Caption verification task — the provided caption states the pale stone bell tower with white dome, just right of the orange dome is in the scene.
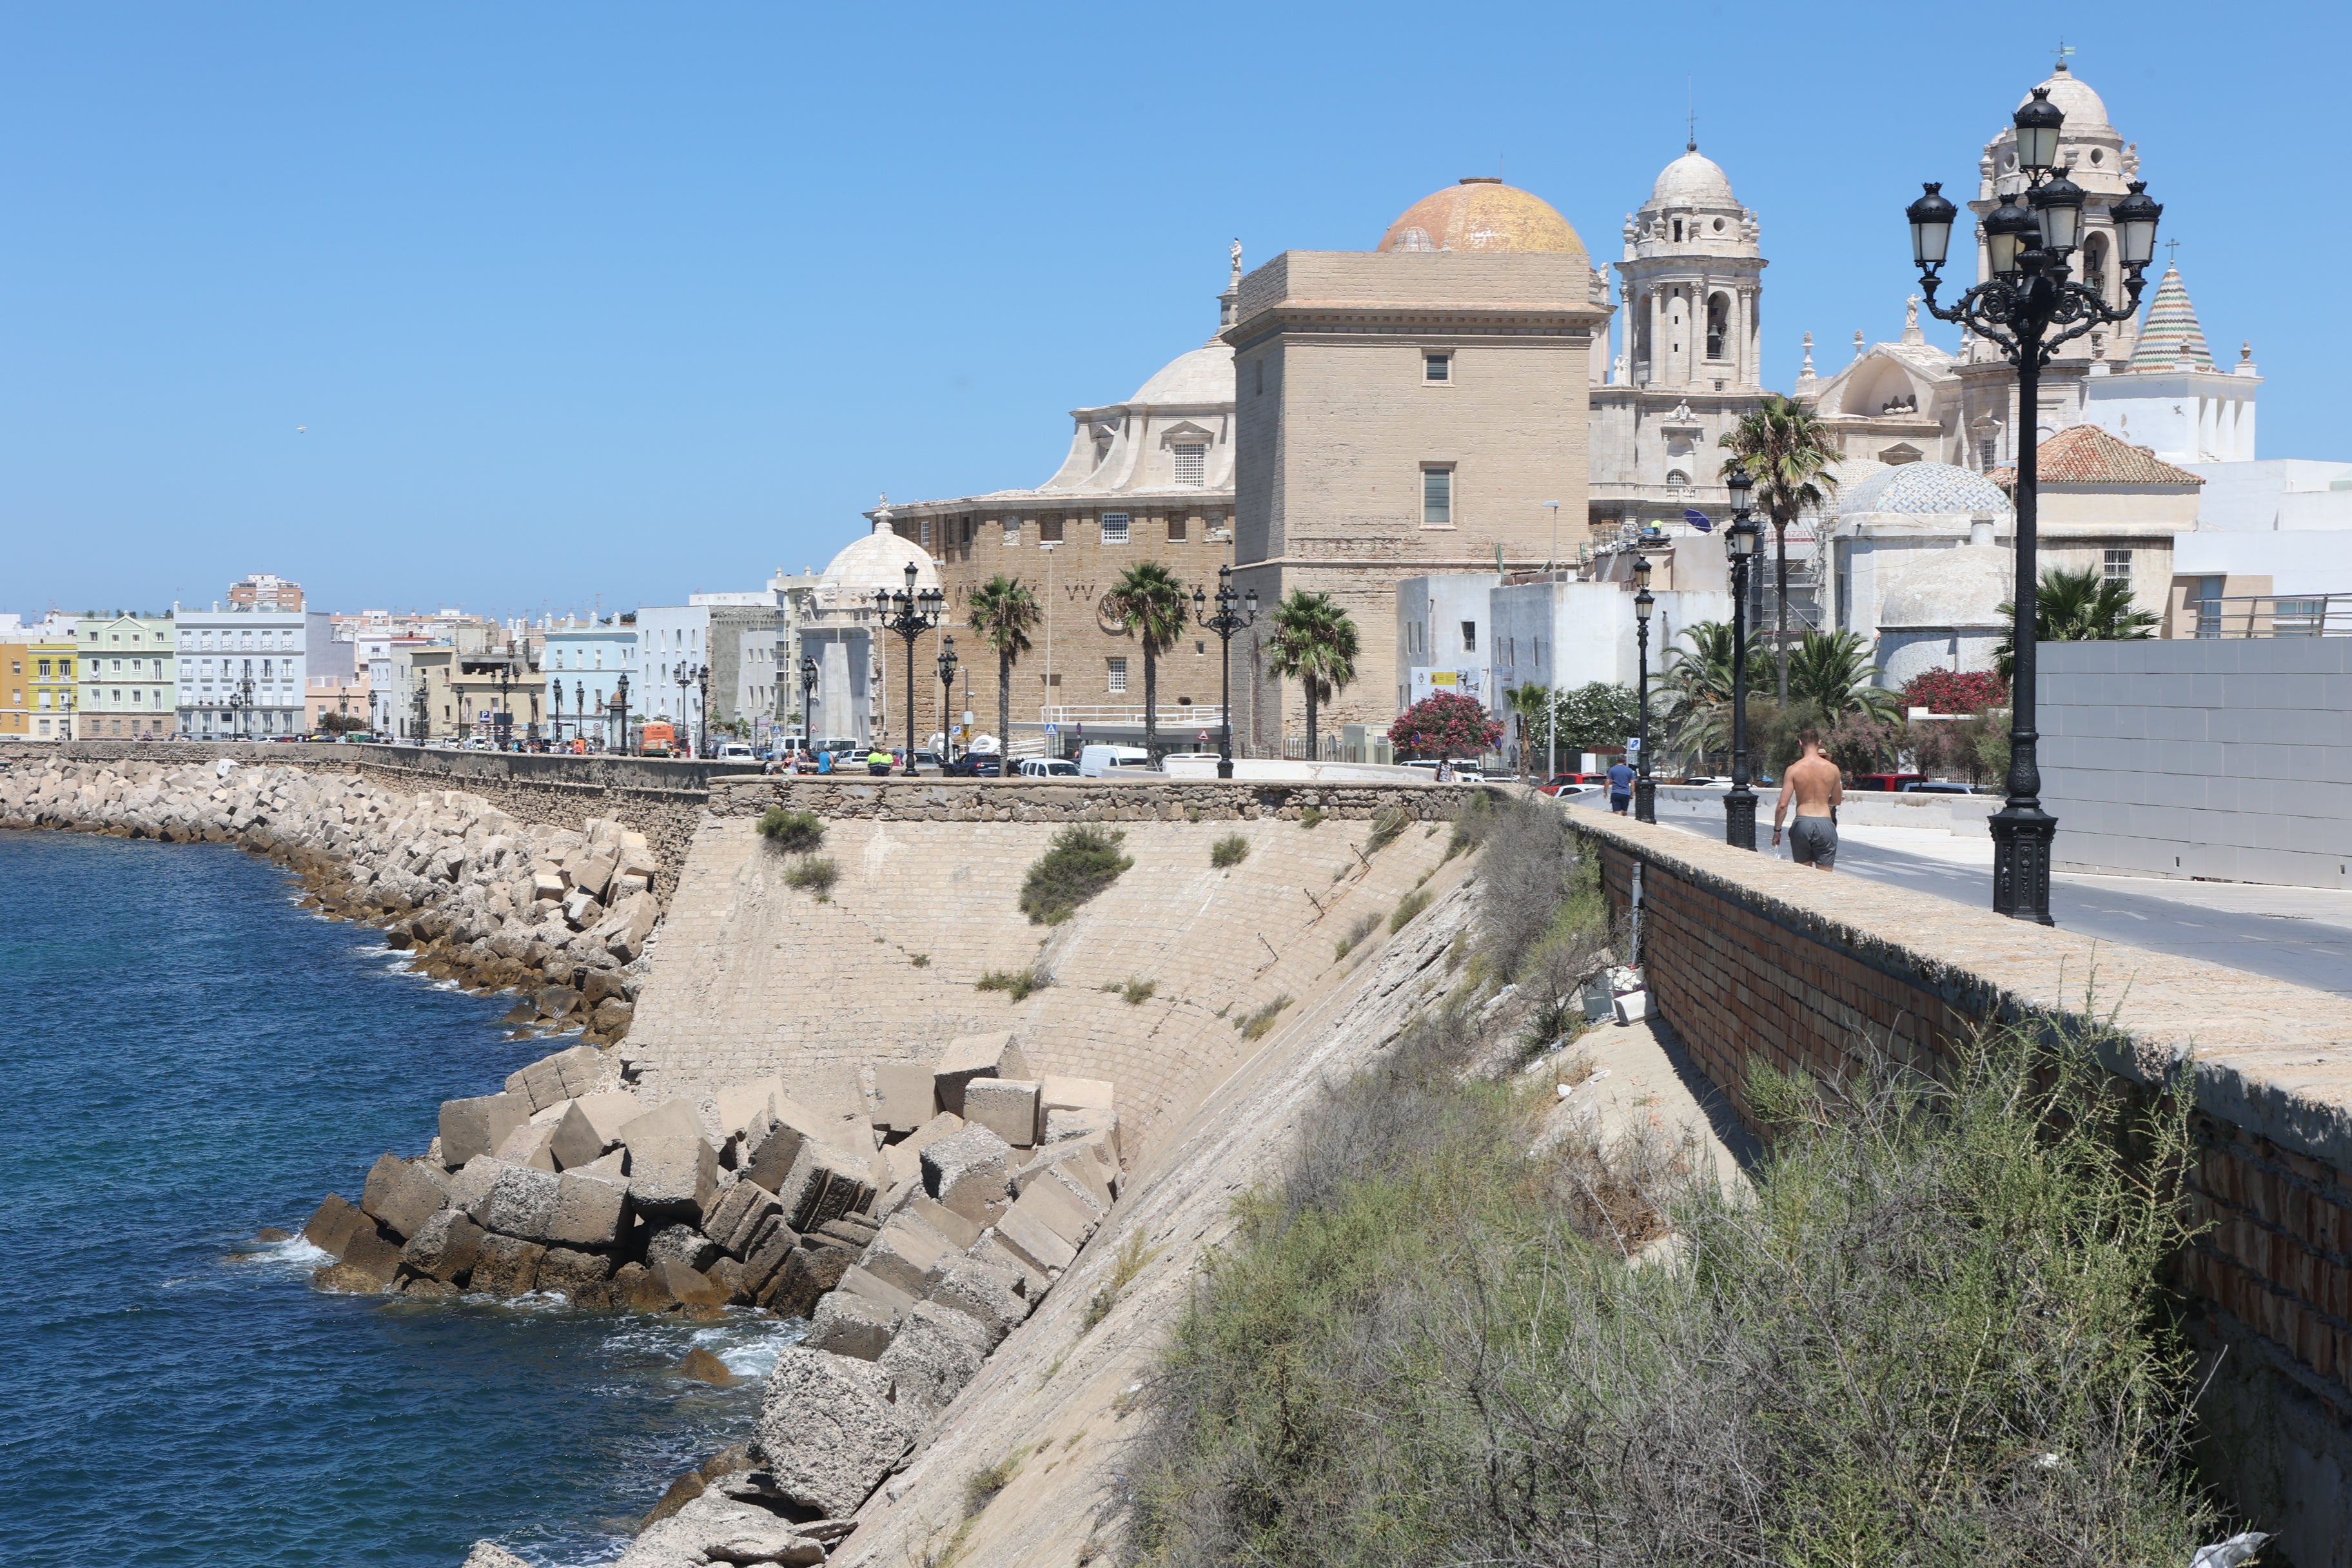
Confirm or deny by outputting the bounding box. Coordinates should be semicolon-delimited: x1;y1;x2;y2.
1614;141;1764;393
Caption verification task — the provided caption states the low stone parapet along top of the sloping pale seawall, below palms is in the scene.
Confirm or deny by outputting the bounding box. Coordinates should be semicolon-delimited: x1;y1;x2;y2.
710;776;1470;823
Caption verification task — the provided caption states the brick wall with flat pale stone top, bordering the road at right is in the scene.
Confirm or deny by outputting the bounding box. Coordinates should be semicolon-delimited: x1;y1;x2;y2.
1571;816;2352;1568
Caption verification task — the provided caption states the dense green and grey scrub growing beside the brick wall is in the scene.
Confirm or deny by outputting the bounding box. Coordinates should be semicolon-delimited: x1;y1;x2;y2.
1122;807;2213;1568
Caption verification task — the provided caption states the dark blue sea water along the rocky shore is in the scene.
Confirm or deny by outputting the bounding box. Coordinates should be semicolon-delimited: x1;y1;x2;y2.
0;832;799;1568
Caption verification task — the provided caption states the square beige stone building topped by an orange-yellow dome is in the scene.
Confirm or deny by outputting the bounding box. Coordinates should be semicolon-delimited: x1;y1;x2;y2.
1223;179;1609;757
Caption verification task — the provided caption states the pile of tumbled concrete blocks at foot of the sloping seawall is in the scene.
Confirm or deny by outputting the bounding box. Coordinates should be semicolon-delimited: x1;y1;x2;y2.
444;1034;1124;1568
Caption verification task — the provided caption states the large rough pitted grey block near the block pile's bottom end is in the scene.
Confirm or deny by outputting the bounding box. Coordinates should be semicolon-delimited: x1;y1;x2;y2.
758;1345;922;1518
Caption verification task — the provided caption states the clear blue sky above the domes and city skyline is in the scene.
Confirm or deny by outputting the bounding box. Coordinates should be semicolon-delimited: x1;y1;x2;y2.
0;3;2352;614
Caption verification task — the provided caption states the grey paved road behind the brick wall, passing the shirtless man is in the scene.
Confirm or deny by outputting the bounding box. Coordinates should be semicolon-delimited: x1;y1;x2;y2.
1571;797;2352;994
